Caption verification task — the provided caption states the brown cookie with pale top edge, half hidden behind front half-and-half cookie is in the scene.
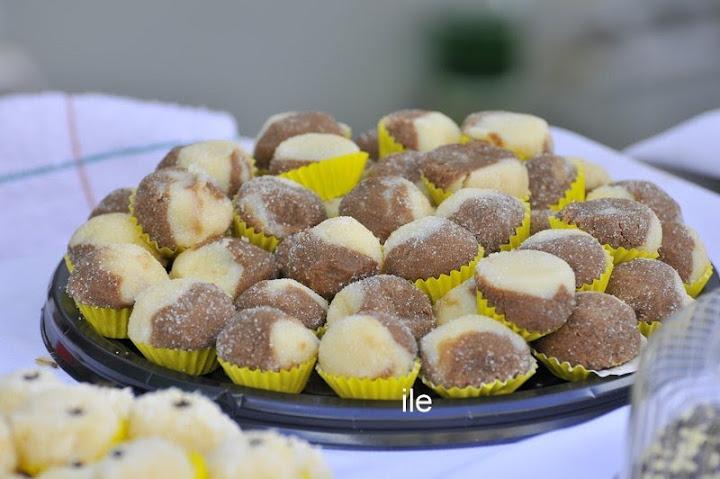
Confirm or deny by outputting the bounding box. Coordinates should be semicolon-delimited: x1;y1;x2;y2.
235;278;328;329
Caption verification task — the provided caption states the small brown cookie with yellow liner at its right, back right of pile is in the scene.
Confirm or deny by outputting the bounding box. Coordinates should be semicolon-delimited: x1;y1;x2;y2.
525;154;585;210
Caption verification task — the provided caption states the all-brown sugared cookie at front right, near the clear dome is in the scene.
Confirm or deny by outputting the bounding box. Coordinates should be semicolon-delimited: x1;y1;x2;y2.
533;292;642;371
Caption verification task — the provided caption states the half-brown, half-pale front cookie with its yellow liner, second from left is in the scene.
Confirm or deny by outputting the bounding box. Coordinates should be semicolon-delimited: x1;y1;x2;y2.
217;306;318;393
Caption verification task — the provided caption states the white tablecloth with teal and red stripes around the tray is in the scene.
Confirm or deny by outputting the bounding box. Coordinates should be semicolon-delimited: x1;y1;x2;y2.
0;93;720;479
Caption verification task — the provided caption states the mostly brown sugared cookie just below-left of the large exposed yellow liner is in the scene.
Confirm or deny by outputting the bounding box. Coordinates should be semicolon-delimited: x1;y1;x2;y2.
233;176;327;239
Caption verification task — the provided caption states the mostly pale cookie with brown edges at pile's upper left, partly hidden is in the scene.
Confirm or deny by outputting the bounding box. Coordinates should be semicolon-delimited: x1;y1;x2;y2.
158;140;255;197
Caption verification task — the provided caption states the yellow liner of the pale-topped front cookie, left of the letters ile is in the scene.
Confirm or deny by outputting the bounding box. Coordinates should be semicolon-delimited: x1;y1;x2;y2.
315;360;420;400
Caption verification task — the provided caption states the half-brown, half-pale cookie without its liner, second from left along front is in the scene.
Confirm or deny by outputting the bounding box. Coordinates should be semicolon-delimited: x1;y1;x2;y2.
217;306;318;371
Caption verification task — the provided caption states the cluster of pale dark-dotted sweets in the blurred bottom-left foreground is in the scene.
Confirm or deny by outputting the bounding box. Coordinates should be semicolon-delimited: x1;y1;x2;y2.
0;369;332;479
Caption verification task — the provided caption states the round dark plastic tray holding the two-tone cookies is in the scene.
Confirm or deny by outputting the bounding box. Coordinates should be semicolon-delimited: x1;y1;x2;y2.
41;262;720;449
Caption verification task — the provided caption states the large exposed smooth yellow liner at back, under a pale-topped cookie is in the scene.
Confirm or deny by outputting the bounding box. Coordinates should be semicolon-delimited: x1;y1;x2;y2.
279;151;368;200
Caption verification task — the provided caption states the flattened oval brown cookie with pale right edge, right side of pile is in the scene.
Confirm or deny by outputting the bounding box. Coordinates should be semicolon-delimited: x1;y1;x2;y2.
556;198;662;251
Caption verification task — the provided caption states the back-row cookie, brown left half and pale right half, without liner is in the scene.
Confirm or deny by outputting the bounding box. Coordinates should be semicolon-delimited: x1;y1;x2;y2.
380;110;460;151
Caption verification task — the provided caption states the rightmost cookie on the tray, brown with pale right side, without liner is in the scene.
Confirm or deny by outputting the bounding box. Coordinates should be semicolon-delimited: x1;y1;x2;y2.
658;222;710;284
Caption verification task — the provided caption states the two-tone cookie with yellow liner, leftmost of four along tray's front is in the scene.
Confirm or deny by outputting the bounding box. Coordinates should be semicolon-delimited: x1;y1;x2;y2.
127;278;235;375
